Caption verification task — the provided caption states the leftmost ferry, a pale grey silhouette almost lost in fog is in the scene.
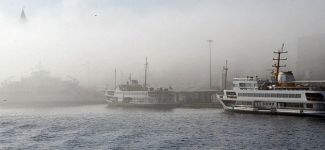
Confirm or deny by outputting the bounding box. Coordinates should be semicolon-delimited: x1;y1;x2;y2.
0;68;105;107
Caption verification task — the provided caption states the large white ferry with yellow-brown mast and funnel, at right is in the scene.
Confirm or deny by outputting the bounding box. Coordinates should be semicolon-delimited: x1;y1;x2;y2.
217;45;325;117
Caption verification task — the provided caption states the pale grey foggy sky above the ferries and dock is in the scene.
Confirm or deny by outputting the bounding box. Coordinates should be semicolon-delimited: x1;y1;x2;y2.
0;0;325;89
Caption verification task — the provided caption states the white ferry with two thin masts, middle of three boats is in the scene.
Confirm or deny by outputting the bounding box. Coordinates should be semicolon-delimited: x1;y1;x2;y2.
105;59;178;108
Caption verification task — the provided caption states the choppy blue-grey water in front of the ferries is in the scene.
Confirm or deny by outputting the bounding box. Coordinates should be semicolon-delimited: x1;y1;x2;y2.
0;105;325;149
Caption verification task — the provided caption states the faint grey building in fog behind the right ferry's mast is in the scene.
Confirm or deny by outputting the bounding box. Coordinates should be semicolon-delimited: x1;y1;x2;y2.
295;34;325;80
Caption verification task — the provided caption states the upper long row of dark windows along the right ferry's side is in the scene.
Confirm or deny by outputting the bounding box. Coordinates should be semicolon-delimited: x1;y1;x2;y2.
238;93;301;98
